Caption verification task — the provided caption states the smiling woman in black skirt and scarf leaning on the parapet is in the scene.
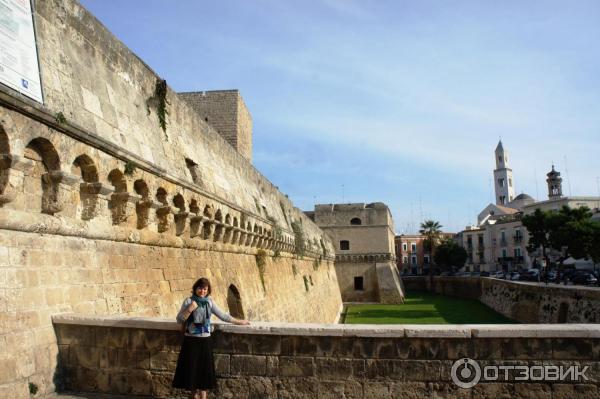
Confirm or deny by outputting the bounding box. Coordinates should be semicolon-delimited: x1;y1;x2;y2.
173;277;250;399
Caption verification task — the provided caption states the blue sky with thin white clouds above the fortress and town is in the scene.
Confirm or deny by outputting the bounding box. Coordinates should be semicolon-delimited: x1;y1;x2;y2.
82;0;600;233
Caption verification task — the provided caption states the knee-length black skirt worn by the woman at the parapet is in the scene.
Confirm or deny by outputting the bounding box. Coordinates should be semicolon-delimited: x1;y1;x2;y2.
173;335;217;391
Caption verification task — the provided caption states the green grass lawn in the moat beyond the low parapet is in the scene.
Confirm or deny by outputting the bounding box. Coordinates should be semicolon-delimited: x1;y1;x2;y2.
345;291;515;324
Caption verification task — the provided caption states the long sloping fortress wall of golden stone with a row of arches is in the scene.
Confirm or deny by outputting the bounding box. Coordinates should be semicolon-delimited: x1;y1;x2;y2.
0;0;341;398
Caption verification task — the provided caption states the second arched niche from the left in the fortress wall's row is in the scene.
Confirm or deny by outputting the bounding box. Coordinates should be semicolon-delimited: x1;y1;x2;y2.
24;137;63;215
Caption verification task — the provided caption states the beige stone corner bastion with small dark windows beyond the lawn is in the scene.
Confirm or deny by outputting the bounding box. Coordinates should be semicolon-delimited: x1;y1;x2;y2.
307;202;404;303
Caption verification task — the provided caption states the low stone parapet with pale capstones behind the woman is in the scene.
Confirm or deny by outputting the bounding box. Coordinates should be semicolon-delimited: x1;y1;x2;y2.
53;314;600;398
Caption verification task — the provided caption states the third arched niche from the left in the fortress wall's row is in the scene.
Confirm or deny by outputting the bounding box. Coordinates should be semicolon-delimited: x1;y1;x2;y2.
71;154;100;220
